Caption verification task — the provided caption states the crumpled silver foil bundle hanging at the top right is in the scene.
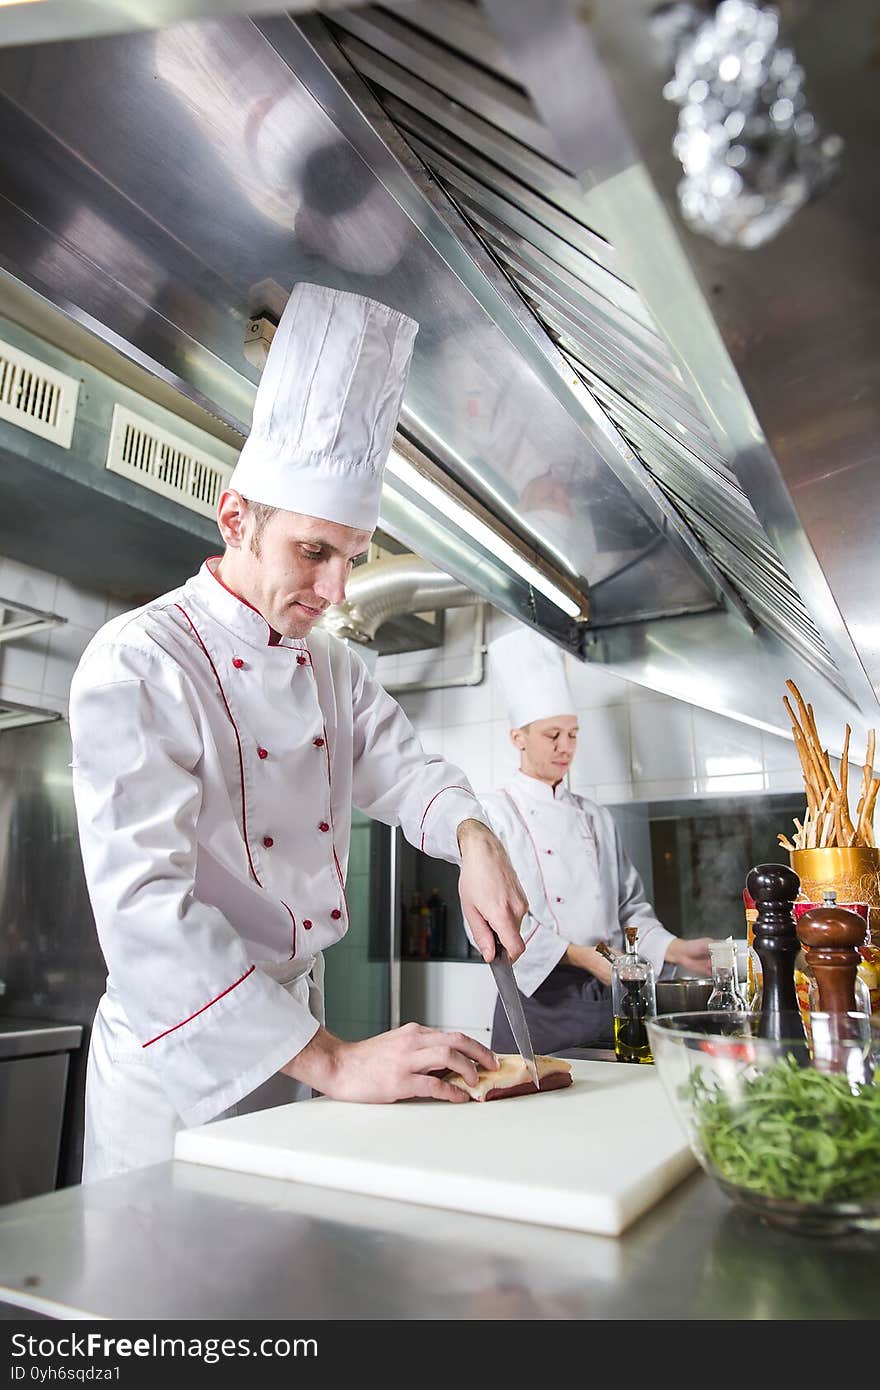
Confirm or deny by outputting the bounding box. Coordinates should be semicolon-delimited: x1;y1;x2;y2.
663;0;844;247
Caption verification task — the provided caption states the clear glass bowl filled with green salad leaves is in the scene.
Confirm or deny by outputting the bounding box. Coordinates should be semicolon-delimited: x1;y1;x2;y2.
646;1012;880;1236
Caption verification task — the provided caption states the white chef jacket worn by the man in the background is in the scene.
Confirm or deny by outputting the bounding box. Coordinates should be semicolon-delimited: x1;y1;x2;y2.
480;771;674;998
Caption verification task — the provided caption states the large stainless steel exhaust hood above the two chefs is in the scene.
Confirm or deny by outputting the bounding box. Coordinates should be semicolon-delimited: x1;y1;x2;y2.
0;0;880;761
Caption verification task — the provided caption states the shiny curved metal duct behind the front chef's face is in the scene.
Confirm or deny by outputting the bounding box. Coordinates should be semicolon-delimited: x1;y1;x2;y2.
323;555;481;645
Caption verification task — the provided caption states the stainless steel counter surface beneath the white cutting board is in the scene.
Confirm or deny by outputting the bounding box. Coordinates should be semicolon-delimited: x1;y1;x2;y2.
0;1162;880;1322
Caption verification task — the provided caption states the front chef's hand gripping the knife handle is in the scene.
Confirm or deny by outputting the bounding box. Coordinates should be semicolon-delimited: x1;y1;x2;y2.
459;820;528;960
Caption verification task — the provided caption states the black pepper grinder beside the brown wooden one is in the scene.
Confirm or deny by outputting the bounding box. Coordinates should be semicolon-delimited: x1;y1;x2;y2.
745;865;805;1040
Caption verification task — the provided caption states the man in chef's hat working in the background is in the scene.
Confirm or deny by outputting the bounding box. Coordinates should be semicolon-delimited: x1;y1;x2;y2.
481;627;710;1054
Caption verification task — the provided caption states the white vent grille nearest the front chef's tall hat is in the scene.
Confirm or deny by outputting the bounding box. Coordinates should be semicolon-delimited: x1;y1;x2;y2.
107;406;232;518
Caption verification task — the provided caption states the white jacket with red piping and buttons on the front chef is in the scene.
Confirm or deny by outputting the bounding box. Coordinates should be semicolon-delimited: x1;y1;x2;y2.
70;557;487;1161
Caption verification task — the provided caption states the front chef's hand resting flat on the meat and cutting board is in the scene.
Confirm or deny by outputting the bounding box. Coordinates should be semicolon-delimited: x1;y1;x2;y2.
281;1023;498;1105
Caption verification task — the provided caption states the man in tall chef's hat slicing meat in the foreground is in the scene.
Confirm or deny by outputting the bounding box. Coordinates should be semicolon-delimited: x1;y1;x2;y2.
70;284;527;1180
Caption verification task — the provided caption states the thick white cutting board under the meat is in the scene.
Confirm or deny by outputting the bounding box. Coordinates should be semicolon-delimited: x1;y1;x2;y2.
175;1062;696;1236
